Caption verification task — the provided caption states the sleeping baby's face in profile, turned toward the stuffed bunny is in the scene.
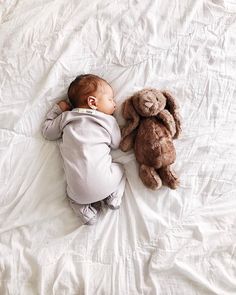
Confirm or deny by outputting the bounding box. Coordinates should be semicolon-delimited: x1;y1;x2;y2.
94;82;116;115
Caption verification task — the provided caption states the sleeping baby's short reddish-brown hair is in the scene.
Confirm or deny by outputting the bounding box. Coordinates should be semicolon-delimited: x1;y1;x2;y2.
67;74;108;108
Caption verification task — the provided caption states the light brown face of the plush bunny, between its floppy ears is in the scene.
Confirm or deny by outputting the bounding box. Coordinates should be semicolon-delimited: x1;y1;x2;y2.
132;89;166;117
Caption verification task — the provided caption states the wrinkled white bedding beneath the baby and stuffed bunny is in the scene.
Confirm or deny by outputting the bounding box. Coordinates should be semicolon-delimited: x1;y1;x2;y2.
0;0;236;295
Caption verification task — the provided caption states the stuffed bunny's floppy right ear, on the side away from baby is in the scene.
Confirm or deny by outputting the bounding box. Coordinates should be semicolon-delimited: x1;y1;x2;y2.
162;90;182;139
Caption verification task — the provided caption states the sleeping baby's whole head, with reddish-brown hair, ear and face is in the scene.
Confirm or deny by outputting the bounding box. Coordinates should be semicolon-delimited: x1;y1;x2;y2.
68;74;115;115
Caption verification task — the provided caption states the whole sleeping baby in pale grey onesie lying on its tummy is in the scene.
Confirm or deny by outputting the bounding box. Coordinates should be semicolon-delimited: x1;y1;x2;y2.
42;74;125;225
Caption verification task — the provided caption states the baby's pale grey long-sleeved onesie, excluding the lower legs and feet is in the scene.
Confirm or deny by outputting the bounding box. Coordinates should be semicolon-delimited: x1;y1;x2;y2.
42;104;124;204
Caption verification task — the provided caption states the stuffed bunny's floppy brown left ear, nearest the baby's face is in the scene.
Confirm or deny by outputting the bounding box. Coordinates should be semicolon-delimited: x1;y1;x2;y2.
122;97;139;138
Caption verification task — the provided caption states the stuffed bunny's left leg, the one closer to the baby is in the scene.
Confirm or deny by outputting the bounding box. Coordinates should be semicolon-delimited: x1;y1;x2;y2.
139;164;162;190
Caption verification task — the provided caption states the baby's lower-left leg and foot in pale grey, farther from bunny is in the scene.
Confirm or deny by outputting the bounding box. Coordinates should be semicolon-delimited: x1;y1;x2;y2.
69;198;98;225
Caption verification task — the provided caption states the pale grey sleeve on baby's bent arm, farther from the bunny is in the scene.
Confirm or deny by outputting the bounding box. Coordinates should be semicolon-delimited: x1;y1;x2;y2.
42;104;63;140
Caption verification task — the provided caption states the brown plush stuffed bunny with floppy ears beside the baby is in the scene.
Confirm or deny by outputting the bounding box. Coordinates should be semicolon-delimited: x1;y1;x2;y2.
120;89;181;189
